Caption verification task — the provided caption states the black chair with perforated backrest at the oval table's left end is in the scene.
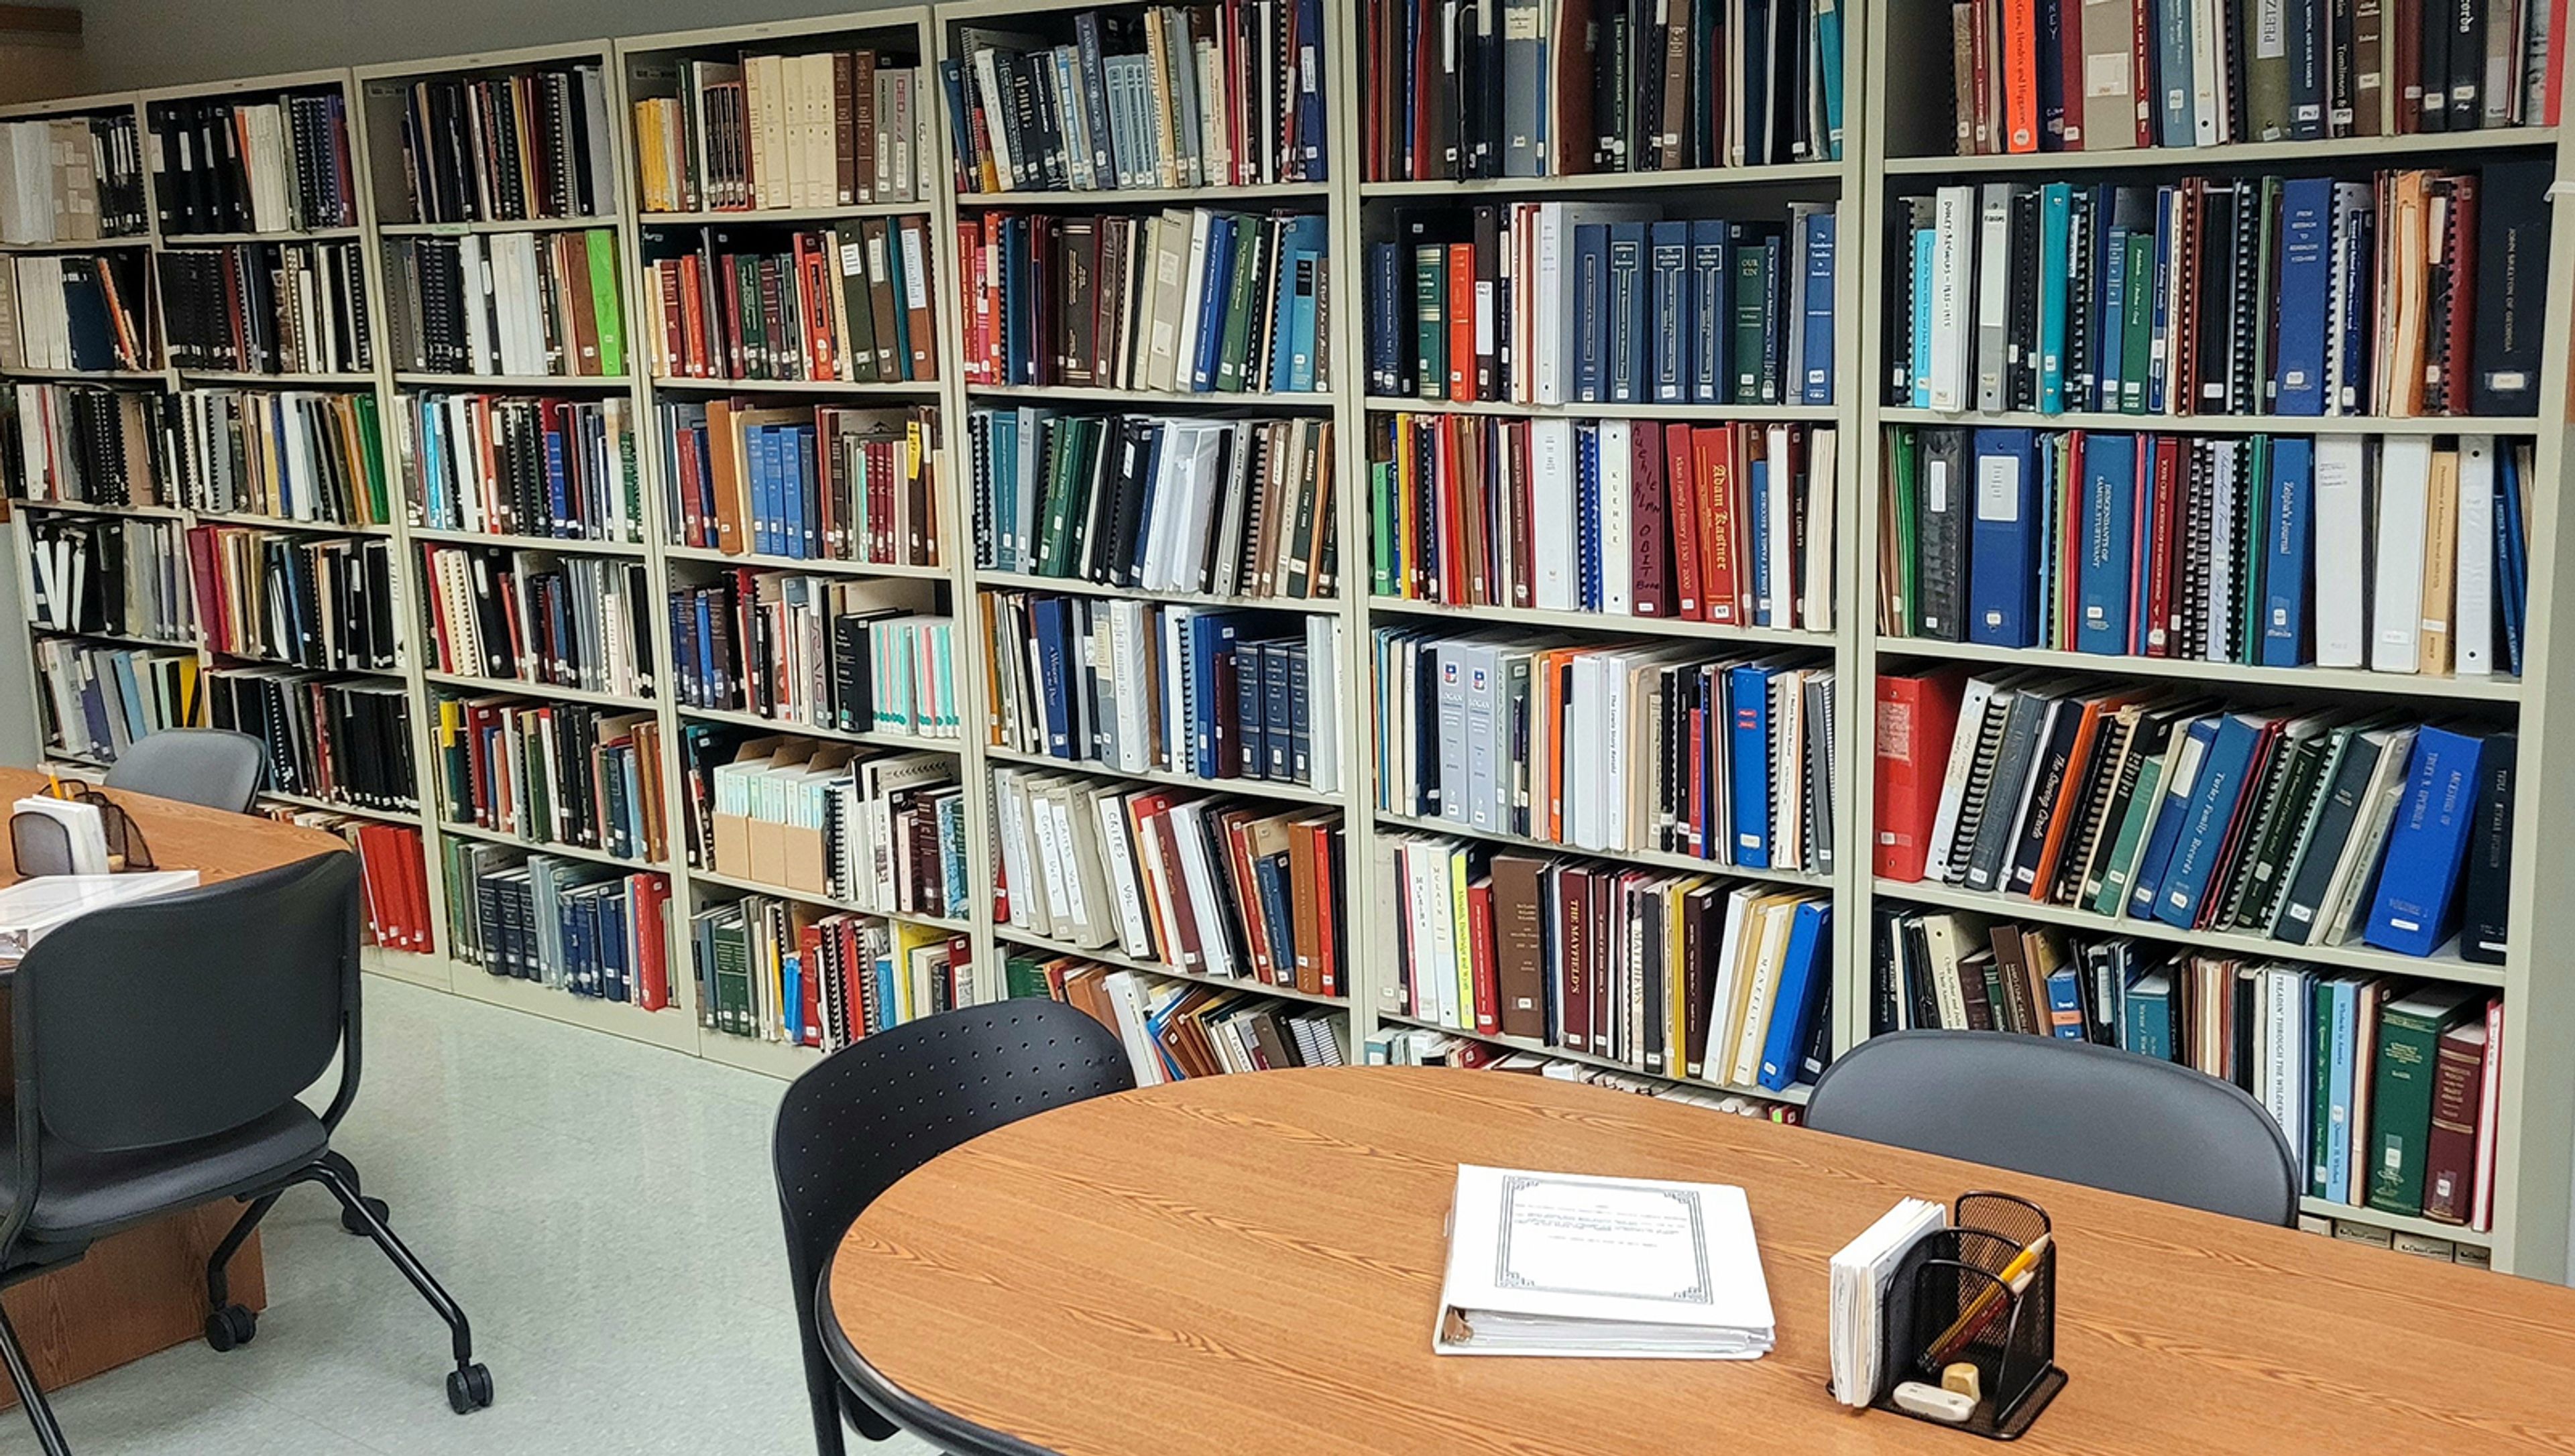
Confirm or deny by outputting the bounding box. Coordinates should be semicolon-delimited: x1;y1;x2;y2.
772;998;1135;1456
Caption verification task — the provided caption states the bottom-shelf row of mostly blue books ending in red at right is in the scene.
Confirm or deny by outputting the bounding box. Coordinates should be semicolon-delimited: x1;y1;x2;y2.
445;839;669;1011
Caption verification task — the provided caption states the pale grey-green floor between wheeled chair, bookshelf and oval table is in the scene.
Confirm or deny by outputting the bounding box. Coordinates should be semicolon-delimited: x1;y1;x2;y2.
0;977;929;1456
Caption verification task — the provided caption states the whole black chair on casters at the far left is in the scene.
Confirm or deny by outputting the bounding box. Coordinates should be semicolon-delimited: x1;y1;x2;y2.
0;854;492;1456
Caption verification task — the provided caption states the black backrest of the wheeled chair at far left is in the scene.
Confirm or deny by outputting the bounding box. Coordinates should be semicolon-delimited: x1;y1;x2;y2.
13;851;361;1152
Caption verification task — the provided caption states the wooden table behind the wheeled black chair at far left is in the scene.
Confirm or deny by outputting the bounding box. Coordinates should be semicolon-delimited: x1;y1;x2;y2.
0;769;347;1410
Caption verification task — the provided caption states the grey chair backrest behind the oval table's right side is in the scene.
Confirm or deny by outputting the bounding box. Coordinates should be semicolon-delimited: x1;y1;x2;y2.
1805;1032;2297;1225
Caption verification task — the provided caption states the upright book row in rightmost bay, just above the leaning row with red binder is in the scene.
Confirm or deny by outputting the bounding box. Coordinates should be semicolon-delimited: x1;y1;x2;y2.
1880;427;2534;676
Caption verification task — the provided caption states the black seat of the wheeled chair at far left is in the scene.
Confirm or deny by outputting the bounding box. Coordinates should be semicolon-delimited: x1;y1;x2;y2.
0;1103;330;1242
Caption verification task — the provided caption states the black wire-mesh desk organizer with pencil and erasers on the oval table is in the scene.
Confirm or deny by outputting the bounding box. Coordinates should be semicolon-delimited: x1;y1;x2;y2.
1870;1194;2065;1441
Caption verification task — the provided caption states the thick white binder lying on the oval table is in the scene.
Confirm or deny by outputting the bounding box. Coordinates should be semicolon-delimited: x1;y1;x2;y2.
1432;1165;1774;1361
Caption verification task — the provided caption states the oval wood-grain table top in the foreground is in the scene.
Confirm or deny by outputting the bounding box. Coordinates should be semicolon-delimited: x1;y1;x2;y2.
832;1068;2575;1456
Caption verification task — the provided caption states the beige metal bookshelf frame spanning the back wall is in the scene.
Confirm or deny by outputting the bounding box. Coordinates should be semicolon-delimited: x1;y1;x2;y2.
0;0;2575;1276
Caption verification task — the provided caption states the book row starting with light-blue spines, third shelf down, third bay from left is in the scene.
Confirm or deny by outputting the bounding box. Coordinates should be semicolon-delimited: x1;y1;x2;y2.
394;393;644;546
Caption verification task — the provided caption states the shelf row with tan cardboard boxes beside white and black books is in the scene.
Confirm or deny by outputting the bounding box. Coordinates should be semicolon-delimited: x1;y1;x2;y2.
680;723;971;918
